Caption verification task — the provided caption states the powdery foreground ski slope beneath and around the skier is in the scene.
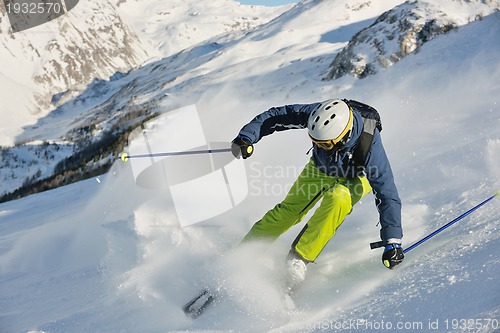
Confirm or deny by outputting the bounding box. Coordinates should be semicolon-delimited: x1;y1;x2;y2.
0;5;500;333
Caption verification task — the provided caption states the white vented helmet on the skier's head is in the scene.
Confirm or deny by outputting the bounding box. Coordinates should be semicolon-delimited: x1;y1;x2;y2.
307;99;353;144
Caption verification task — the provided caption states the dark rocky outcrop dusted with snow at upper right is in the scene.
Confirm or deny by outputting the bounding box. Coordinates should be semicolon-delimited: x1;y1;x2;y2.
326;0;500;80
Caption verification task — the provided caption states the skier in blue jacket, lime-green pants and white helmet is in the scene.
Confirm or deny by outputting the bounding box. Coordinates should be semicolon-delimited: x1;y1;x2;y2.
232;99;404;293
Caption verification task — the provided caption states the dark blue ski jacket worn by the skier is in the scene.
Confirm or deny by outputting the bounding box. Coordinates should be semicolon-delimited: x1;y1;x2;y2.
239;103;403;243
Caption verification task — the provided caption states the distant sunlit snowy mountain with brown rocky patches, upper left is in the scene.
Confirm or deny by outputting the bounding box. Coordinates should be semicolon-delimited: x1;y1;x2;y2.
0;0;288;146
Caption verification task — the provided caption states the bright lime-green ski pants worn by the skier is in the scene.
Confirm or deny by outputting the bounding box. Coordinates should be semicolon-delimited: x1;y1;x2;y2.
243;160;371;261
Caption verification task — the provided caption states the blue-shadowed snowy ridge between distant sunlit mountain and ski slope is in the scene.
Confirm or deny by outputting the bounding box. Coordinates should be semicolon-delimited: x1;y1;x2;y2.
0;0;401;200
